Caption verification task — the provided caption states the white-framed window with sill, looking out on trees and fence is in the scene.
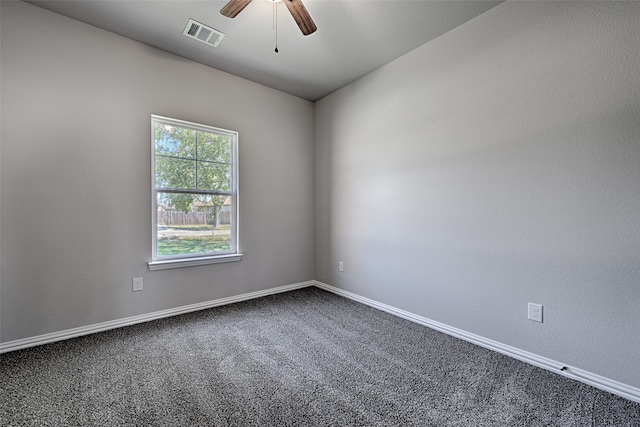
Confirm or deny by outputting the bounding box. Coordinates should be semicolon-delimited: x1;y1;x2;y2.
149;116;242;270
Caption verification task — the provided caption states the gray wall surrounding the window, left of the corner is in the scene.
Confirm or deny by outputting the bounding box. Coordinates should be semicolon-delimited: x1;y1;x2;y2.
0;1;314;342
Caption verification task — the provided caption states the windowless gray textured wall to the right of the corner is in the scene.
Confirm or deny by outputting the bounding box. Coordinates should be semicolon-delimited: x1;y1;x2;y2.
315;2;640;387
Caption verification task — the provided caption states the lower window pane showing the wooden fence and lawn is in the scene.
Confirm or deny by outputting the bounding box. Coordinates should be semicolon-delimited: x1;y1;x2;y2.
157;192;232;256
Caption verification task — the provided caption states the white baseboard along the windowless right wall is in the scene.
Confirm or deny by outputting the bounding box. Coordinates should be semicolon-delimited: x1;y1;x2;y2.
313;280;640;403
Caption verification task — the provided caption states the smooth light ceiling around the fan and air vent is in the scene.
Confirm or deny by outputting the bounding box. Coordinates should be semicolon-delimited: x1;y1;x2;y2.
28;0;500;101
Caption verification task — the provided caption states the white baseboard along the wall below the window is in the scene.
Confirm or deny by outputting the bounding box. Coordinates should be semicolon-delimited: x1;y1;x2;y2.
0;281;314;353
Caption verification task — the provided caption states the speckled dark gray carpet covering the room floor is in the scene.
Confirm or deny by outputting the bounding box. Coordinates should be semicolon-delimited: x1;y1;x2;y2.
0;288;640;426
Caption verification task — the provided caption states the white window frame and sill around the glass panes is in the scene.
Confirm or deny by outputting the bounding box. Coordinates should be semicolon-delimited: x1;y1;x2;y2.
148;115;242;270
